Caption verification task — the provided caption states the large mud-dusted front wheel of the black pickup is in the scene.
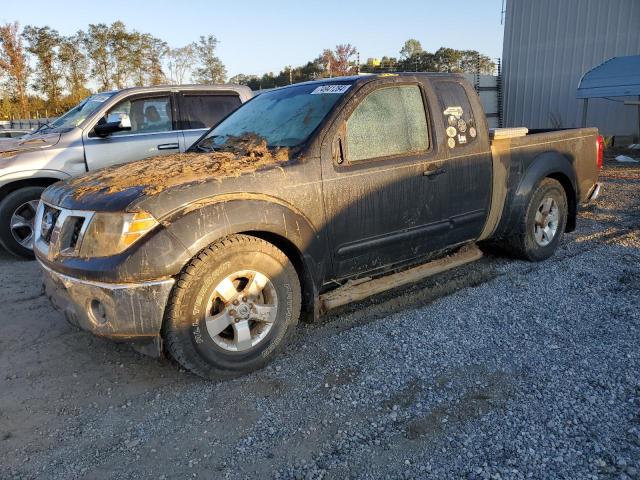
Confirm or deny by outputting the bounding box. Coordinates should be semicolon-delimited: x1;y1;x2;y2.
163;235;301;379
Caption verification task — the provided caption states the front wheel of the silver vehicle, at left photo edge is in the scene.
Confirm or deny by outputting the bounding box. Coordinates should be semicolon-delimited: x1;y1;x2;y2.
0;187;44;259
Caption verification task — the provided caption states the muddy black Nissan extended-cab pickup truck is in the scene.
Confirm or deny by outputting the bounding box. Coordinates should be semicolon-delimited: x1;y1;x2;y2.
34;74;602;378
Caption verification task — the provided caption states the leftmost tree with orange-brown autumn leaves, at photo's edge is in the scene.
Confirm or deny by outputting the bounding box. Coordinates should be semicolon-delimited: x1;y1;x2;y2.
0;22;29;117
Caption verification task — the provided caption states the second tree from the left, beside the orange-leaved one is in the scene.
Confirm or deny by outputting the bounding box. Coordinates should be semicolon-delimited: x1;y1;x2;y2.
22;25;62;108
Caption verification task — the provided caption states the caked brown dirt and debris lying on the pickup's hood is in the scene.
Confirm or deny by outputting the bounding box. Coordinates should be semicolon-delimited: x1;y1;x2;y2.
69;135;289;198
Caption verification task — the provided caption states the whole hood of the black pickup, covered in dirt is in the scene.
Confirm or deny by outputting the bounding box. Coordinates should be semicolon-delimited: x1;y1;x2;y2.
42;140;289;213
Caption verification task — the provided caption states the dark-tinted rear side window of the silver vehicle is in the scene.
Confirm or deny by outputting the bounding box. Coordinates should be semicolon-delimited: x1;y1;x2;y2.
180;94;240;130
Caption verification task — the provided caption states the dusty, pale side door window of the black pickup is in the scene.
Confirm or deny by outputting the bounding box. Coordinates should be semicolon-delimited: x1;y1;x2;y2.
346;85;429;161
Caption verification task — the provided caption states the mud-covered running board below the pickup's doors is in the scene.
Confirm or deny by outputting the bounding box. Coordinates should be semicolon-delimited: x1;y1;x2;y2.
320;244;482;312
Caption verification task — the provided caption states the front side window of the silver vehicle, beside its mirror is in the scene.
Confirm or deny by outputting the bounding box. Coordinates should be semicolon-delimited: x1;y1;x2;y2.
107;96;173;136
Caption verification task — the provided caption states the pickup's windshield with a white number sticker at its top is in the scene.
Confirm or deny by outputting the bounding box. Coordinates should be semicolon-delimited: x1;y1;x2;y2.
196;83;351;150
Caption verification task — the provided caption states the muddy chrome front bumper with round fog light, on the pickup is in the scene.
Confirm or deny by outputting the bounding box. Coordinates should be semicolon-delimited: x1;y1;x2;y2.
40;262;175;350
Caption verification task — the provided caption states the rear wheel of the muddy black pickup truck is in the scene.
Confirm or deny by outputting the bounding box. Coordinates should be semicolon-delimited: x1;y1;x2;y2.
506;178;568;262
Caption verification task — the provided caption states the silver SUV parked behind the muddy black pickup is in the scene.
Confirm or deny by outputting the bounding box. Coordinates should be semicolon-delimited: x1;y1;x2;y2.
0;85;252;258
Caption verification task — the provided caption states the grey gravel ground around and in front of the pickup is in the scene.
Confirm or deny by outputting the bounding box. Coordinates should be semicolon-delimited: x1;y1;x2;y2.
0;158;640;479
